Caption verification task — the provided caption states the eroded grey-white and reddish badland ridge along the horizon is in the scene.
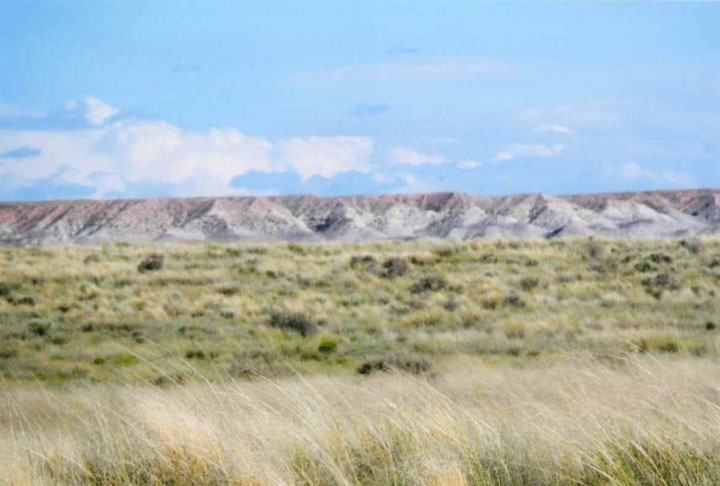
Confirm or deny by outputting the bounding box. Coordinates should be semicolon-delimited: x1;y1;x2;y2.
0;190;720;246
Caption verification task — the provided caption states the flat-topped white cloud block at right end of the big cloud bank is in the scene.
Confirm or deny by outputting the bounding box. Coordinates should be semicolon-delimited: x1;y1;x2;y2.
280;137;373;180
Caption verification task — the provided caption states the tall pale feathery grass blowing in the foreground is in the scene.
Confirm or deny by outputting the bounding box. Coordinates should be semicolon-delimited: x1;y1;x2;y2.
0;356;720;486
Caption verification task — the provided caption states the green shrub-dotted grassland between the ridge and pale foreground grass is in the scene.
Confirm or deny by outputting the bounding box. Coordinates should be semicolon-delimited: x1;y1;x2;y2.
0;240;720;383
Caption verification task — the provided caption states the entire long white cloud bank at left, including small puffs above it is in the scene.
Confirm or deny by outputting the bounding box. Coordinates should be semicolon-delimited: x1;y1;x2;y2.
0;111;372;198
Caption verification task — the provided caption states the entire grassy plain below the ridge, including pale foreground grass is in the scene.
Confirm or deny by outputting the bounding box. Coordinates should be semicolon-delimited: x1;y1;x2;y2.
0;239;720;486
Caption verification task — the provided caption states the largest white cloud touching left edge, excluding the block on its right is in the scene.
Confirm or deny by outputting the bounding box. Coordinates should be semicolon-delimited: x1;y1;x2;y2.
0;122;273;197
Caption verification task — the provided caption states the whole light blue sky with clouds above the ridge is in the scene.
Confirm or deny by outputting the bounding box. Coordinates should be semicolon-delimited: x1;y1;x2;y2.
0;0;720;201
